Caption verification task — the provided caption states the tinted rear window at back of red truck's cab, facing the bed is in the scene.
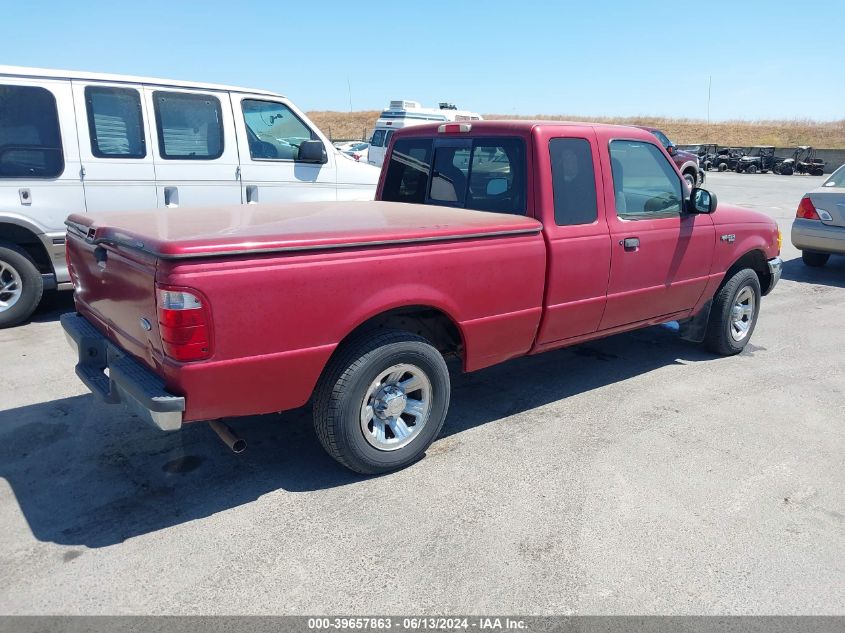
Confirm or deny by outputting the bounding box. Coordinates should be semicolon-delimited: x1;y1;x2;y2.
382;138;526;215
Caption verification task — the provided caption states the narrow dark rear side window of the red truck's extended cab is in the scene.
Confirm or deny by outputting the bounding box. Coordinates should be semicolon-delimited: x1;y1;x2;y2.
549;138;598;226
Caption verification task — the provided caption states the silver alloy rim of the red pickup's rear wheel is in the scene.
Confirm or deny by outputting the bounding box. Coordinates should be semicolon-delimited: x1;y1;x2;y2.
361;363;432;451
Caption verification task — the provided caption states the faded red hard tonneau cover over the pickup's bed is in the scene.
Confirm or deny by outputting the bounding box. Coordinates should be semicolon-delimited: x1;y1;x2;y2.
66;201;542;259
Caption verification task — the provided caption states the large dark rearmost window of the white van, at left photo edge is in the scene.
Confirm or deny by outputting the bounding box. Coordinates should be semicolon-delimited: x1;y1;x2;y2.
0;85;65;178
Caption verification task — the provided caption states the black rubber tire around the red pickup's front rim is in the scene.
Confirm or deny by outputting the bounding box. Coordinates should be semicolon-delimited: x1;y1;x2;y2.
704;268;762;356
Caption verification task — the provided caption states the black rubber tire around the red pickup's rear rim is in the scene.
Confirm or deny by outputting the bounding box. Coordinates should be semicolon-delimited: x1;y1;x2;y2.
314;330;450;475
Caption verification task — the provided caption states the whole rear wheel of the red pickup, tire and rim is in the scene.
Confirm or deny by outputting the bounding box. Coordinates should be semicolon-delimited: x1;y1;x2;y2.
314;330;450;475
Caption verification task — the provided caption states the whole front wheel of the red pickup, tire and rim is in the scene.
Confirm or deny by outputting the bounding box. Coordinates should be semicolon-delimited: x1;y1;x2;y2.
704;268;762;356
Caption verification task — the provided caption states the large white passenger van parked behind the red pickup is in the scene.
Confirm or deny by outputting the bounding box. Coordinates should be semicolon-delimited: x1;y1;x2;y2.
0;66;379;327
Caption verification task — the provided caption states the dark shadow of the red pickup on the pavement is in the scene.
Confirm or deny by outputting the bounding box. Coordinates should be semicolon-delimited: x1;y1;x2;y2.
0;327;714;547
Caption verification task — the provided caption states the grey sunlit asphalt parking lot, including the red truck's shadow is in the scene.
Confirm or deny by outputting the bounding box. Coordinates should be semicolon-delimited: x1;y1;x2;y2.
0;173;845;614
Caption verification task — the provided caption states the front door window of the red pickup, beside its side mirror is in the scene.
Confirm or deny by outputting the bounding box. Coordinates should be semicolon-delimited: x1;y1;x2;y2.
610;141;683;220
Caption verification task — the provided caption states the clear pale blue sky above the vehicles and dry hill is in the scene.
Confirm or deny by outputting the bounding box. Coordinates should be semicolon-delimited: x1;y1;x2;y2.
0;0;845;121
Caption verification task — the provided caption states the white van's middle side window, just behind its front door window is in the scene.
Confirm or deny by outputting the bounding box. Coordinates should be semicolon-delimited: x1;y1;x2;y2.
153;90;223;160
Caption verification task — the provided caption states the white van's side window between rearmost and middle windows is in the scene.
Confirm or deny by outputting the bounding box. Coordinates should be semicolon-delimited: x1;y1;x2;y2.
85;86;147;158
